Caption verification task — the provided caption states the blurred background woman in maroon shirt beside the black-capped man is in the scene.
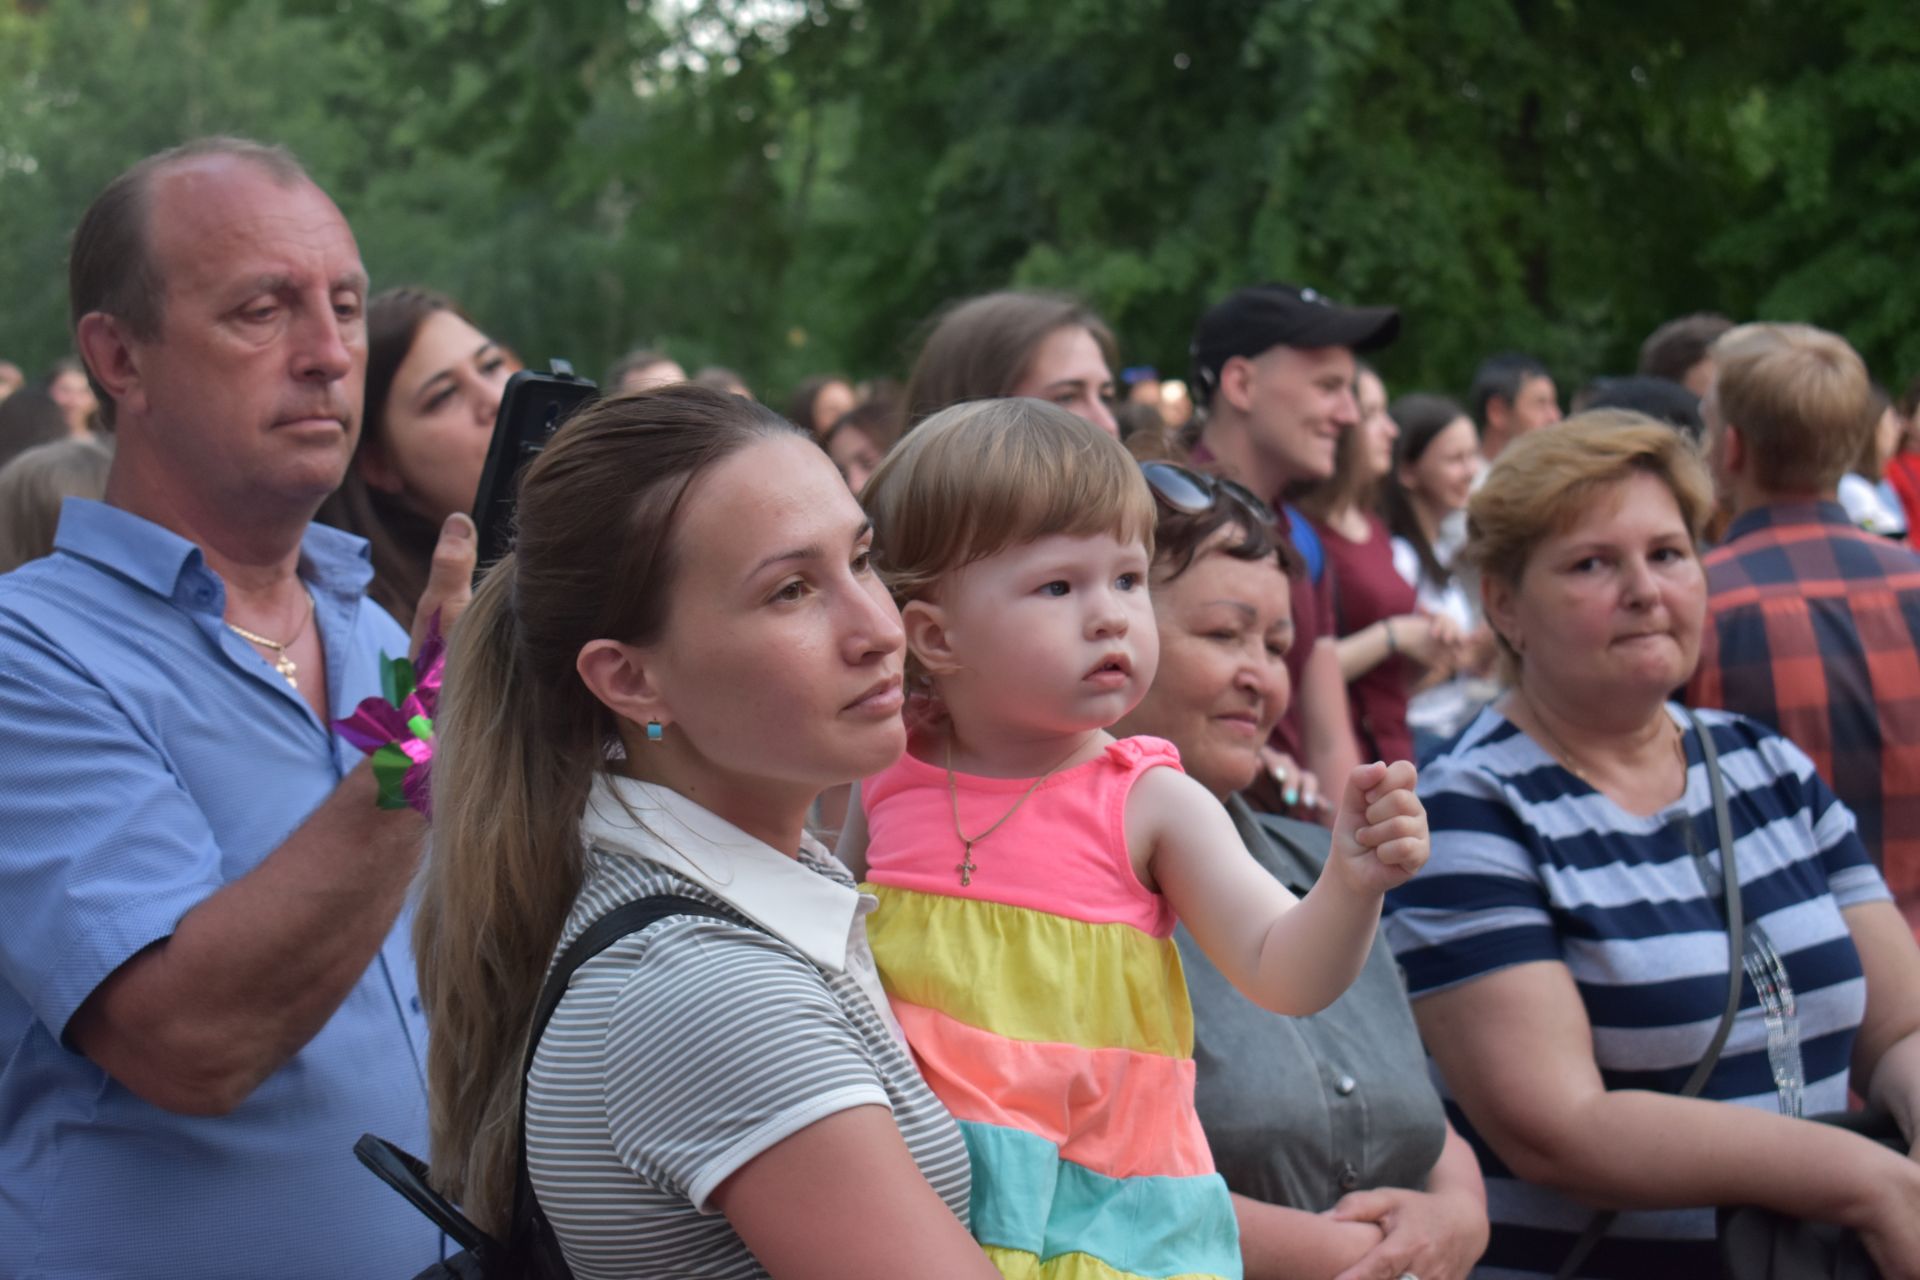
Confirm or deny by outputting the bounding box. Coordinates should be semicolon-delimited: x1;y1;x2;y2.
1300;365;1459;762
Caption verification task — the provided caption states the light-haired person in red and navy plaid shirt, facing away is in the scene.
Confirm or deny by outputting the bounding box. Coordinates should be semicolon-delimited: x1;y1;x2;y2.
1686;324;1920;931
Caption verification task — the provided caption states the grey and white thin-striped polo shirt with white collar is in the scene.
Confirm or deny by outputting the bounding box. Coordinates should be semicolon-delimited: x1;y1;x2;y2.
526;777;970;1280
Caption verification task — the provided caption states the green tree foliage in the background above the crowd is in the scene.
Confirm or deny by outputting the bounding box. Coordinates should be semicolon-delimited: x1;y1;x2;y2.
0;0;1920;401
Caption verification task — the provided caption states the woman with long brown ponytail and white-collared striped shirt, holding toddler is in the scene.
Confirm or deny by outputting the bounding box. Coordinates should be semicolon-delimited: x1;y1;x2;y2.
415;386;995;1280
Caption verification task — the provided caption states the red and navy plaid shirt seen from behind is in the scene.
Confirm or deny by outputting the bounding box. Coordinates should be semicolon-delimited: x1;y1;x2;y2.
1686;503;1920;927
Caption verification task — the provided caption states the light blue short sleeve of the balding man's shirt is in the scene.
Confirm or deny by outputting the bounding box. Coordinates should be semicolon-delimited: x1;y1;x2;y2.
0;618;226;1038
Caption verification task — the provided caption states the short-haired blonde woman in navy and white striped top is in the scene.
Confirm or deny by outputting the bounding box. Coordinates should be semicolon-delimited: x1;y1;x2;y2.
1388;411;1920;1280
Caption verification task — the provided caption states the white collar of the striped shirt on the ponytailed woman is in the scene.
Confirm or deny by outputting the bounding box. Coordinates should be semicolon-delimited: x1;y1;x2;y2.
580;773;860;973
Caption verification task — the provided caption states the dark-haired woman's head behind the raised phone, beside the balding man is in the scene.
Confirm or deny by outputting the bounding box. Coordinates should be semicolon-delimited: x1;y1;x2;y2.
319;286;520;629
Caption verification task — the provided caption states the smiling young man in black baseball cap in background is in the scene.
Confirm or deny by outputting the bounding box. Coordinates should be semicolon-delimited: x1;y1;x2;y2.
1190;284;1400;818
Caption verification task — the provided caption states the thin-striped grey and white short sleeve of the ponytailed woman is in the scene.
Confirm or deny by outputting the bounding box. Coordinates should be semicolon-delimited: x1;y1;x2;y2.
603;921;891;1213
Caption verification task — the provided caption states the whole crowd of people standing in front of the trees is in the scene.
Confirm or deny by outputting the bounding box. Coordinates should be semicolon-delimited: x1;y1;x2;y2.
0;140;1920;1280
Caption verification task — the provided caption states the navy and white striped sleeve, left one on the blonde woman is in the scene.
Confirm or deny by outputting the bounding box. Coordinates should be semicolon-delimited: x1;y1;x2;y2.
1384;756;1563;998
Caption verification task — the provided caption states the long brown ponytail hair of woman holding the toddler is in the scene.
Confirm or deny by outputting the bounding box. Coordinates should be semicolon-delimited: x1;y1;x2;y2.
413;386;801;1230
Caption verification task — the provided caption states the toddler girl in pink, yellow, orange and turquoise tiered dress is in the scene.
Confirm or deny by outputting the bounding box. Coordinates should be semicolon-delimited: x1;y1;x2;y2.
841;399;1427;1280
